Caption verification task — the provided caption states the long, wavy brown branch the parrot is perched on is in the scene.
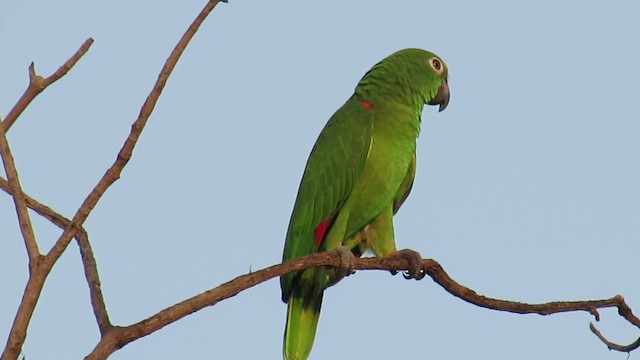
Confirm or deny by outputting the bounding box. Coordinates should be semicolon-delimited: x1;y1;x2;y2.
85;251;640;360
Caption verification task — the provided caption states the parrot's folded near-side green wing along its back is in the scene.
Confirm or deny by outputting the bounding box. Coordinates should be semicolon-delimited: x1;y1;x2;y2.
280;95;373;301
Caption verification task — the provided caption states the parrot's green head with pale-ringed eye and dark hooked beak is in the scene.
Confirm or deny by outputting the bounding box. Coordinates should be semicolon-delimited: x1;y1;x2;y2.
356;48;450;111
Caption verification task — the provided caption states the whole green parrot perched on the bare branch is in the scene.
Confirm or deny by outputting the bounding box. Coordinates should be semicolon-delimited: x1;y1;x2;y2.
280;49;449;360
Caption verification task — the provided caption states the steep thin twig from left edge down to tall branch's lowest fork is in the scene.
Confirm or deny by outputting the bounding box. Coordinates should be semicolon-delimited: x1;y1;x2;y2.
0;111;40;262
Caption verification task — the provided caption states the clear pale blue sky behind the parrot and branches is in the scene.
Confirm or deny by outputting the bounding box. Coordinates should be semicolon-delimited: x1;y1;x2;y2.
0;0;640;360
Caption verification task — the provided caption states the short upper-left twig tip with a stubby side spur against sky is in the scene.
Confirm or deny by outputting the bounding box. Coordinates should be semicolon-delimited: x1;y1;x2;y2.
2;38;93;132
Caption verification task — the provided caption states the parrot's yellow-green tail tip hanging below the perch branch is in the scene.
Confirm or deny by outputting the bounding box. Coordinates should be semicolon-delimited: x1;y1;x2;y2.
283;289;323;360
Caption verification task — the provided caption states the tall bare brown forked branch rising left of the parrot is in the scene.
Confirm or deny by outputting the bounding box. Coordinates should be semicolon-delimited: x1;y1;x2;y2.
0;0;228;360
